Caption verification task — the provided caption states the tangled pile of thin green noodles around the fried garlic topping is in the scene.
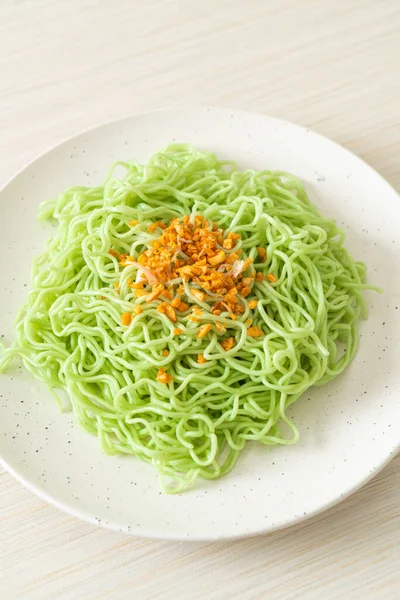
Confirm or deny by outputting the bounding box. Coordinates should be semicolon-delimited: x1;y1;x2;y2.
0;145;376;492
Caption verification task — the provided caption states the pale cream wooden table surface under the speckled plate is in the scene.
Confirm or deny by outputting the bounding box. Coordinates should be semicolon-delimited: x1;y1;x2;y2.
0;0;400;600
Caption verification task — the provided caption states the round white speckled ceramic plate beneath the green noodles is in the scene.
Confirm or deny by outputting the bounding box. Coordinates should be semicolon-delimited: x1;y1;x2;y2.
0;109;400;540
